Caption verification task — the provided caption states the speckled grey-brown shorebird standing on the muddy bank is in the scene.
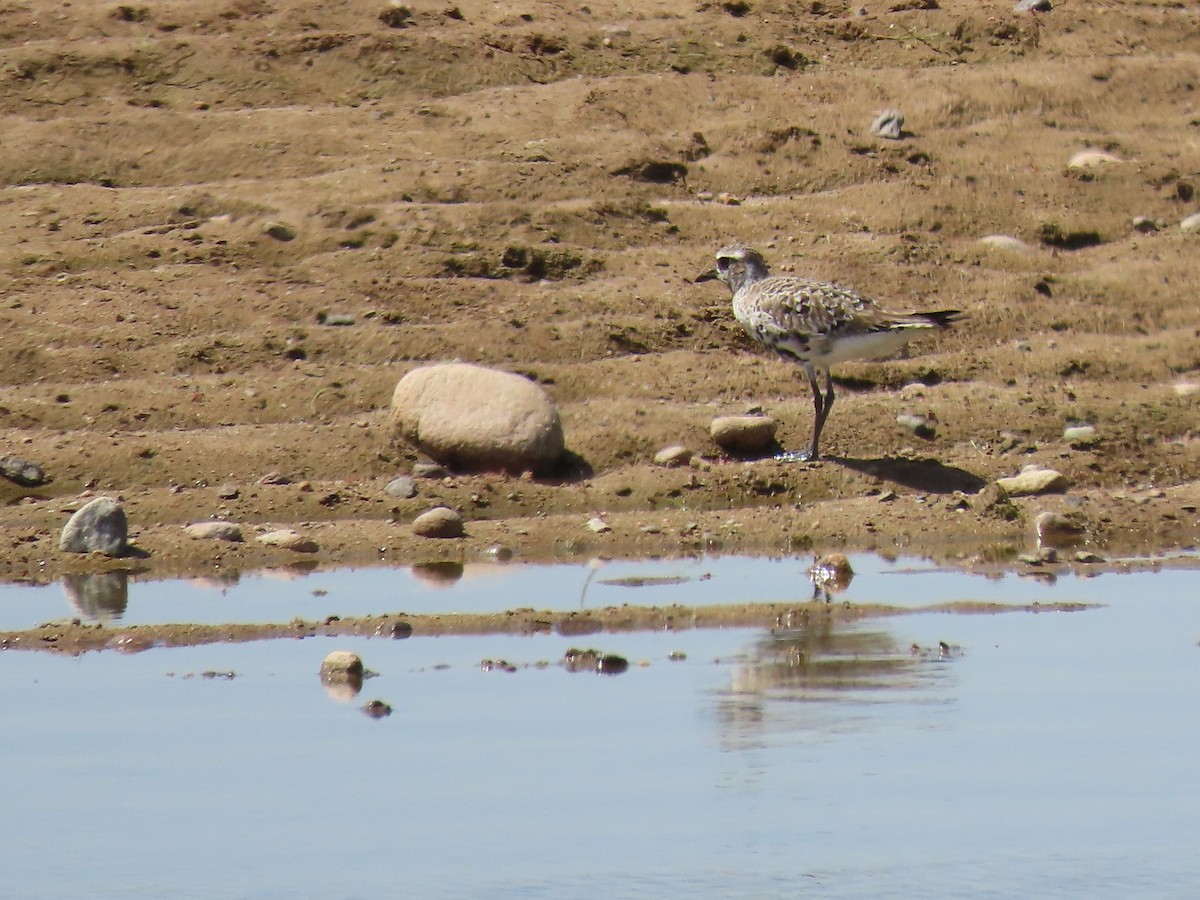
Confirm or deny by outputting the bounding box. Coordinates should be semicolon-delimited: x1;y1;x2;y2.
716;245;961;460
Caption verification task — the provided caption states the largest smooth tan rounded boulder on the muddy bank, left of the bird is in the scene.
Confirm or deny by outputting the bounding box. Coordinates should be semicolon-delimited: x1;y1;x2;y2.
391;362;564;473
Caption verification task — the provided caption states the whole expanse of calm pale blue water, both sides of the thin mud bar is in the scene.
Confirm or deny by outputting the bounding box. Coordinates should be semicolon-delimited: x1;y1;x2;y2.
0;558;1200;898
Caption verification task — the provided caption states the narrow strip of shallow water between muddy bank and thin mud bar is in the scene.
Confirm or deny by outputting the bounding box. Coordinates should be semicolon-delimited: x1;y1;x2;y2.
0;553;1195;630
